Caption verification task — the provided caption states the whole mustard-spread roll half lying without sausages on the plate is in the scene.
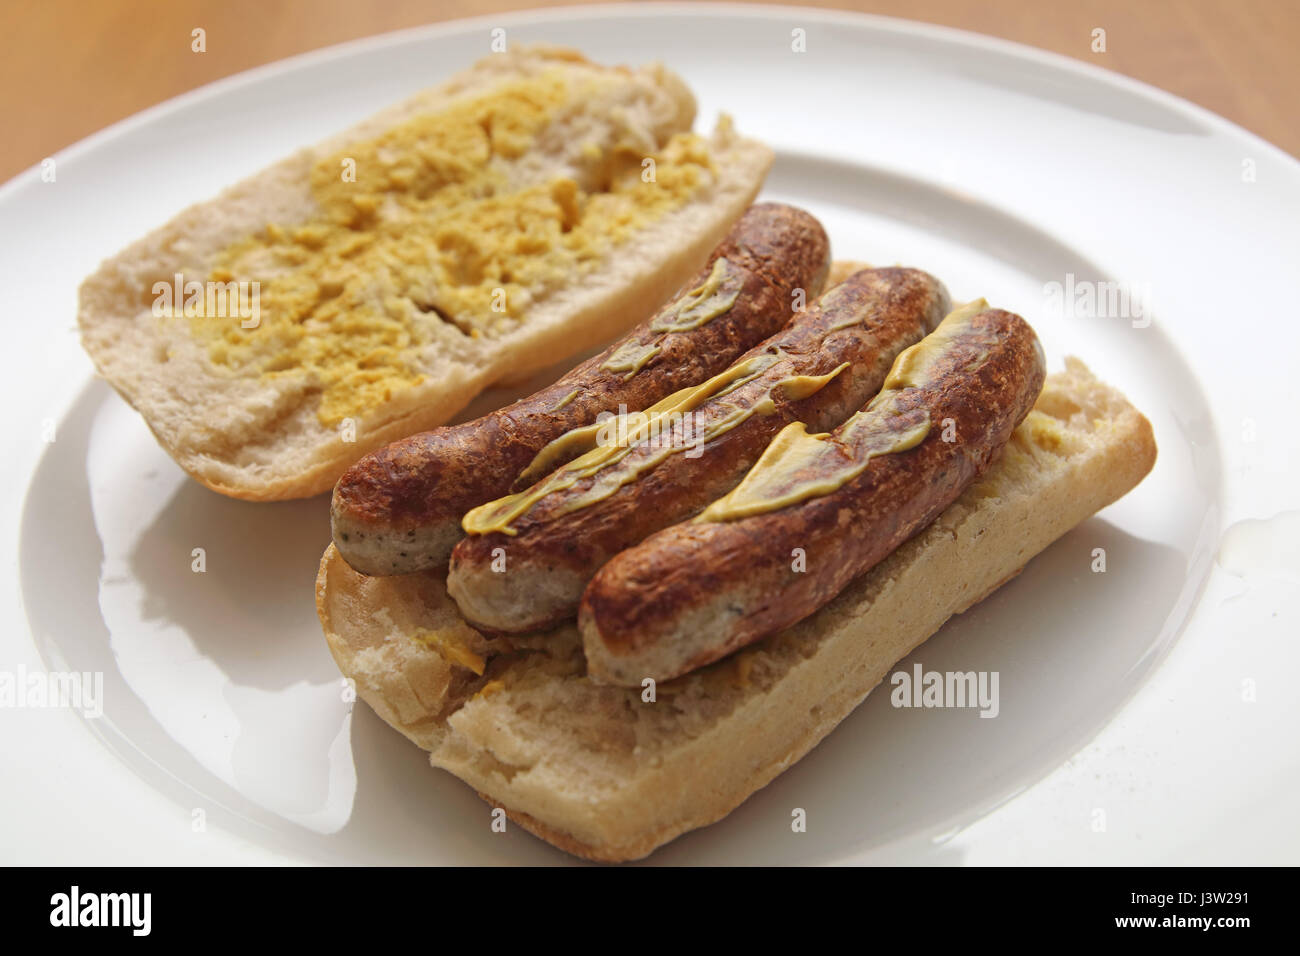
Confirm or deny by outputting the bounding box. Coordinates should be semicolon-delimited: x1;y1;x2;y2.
78;47;772;499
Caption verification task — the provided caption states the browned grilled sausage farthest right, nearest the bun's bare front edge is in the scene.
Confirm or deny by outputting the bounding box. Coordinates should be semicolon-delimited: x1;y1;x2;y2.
579;302;1044;685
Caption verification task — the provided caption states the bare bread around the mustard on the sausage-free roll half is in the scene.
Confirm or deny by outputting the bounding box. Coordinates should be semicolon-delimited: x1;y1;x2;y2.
78;47;772;501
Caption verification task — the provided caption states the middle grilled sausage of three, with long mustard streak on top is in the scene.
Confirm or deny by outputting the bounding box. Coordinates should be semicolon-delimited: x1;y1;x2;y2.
447;268;949;632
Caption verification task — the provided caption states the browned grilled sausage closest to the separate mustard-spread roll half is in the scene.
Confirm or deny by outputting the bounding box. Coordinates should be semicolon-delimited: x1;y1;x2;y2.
330;203;829;575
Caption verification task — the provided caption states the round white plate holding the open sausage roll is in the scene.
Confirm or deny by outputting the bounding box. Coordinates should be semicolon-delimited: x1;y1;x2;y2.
0;4;1300;864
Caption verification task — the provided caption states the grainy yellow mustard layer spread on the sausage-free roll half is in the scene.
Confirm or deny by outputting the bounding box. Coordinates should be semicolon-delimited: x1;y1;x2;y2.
191;70;711;425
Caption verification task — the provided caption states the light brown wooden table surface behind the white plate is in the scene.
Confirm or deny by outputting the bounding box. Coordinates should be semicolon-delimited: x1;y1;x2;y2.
0;0;1300;182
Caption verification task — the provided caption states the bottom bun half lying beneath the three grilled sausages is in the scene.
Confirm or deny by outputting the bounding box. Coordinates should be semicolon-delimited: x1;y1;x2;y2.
316;359;1156;861
